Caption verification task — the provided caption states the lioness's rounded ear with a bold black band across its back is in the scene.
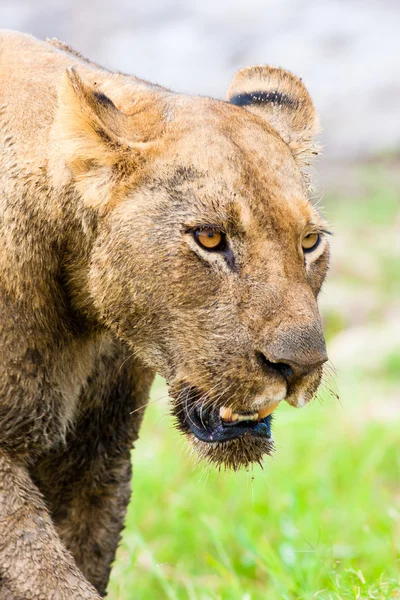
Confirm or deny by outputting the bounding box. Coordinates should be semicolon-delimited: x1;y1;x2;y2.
228;66;319;165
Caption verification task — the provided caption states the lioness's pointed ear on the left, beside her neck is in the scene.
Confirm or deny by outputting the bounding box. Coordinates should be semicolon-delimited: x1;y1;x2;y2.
52;68;155;208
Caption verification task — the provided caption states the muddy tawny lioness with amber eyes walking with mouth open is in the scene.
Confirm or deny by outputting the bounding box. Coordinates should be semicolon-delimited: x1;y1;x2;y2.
0;32;328;600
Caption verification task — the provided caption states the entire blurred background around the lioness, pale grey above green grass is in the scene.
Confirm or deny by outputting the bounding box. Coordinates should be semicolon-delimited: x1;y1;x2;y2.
0;0;400;600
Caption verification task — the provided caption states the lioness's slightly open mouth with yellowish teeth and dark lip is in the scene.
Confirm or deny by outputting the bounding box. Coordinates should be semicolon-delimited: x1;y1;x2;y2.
179;386;272;443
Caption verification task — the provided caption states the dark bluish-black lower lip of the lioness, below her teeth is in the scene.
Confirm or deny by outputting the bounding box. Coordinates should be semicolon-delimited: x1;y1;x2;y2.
179;391;272;443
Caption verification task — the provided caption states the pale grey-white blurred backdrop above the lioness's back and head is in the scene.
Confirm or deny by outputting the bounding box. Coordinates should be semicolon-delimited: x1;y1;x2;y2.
0;0;400;161
